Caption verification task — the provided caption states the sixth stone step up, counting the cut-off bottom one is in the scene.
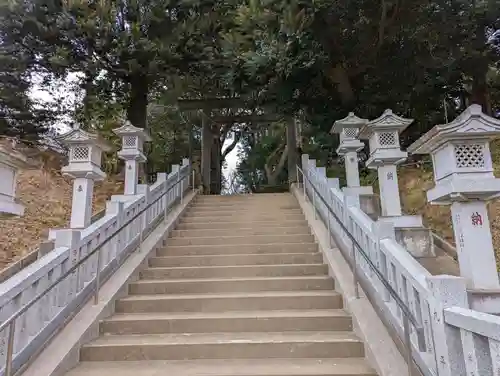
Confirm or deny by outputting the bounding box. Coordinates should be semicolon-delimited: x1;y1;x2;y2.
140;264;328;279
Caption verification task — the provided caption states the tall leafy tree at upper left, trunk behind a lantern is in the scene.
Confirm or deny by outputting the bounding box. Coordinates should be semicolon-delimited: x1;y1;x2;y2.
0;0;223;131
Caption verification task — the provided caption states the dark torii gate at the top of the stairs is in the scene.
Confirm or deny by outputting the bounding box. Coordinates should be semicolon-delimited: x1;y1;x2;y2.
178;98;298;194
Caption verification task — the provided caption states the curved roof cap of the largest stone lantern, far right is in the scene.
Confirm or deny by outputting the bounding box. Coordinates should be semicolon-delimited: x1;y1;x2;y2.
408;104;500;154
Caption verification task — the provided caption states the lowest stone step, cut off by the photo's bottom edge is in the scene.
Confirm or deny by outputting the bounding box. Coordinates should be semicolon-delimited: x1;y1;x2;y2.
67;358;376;376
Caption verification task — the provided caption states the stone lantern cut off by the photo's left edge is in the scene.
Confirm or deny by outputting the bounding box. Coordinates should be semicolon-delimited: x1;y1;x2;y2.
0;145;30;217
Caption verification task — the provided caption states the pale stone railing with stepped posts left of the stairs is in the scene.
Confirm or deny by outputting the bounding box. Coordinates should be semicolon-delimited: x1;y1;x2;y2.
0;160;191;375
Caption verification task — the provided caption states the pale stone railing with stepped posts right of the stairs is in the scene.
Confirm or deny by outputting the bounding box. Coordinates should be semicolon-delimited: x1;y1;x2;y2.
302;155;500;376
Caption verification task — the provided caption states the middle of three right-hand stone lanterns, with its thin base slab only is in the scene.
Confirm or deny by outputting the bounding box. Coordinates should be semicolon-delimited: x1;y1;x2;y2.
359;110;423;228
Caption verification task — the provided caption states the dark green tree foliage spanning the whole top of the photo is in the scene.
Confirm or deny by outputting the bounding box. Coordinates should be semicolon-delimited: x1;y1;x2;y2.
0;0;500;190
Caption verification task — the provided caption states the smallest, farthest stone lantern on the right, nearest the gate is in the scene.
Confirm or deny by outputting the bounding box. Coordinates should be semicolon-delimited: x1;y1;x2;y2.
330;112;373;204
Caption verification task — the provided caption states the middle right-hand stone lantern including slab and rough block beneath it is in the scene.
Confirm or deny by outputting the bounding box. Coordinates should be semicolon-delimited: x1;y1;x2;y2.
359;110;435;257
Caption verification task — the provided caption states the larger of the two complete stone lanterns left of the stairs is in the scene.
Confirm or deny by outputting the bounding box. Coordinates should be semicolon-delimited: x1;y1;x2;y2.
58;125;111;228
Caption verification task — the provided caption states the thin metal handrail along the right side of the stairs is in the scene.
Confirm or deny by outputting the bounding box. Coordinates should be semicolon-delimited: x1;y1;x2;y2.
297;166;426;376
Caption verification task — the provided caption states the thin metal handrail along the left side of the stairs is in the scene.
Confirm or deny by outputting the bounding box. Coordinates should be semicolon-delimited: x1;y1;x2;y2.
0;173;189;376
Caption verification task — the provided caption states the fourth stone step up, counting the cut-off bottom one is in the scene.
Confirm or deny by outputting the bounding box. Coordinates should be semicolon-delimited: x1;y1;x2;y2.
115;290;343;313
